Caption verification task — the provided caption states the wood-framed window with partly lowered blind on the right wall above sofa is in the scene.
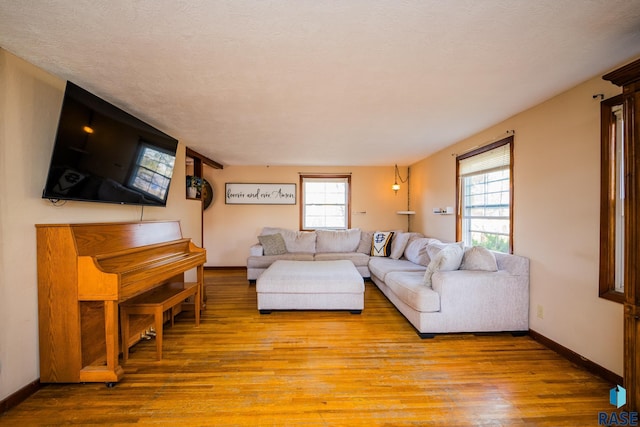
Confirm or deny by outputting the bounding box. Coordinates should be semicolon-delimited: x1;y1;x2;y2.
456;136;513;253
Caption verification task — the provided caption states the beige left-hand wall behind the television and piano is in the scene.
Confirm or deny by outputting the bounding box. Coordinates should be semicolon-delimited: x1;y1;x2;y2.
0;49;201;400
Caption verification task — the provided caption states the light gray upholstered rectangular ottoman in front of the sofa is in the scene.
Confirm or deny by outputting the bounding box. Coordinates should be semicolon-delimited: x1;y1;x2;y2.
256;260;364;314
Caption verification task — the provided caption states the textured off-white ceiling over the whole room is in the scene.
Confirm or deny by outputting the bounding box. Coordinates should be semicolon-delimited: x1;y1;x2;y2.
0;0;640;166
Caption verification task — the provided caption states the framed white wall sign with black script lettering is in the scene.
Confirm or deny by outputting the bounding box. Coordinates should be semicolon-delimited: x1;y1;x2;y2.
224;182;296;205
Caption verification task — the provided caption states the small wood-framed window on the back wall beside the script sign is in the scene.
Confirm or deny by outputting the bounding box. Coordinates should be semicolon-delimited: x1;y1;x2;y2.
300;175;351;230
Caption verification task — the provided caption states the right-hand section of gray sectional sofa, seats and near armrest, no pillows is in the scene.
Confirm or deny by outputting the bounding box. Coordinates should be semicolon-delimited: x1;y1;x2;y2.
370;252;529;337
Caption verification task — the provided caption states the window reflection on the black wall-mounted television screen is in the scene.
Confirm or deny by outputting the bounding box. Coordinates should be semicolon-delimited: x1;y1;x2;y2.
129;143;176;200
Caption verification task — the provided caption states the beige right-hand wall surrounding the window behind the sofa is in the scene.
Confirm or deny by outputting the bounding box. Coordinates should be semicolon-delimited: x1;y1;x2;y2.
411;65;623;375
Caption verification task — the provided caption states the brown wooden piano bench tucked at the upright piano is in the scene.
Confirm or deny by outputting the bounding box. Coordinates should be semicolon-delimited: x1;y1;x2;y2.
120;282;201;362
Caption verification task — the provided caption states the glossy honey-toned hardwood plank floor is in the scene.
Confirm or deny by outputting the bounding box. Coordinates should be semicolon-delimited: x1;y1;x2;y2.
0;270;615;427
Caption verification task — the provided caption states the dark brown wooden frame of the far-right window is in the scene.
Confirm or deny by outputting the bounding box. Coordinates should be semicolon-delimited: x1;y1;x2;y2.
598;94;629;303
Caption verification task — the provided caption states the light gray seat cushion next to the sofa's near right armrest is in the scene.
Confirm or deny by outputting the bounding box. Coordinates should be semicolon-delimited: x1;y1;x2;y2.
385;271;440;313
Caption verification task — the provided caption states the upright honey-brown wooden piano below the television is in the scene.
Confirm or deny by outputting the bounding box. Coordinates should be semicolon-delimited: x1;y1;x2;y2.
36;221;206;384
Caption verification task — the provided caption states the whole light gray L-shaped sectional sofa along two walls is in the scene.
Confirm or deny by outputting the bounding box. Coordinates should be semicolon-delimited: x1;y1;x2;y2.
247;228;529;338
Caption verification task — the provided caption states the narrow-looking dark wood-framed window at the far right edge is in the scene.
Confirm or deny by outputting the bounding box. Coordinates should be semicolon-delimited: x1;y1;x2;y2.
600;95;626;302
